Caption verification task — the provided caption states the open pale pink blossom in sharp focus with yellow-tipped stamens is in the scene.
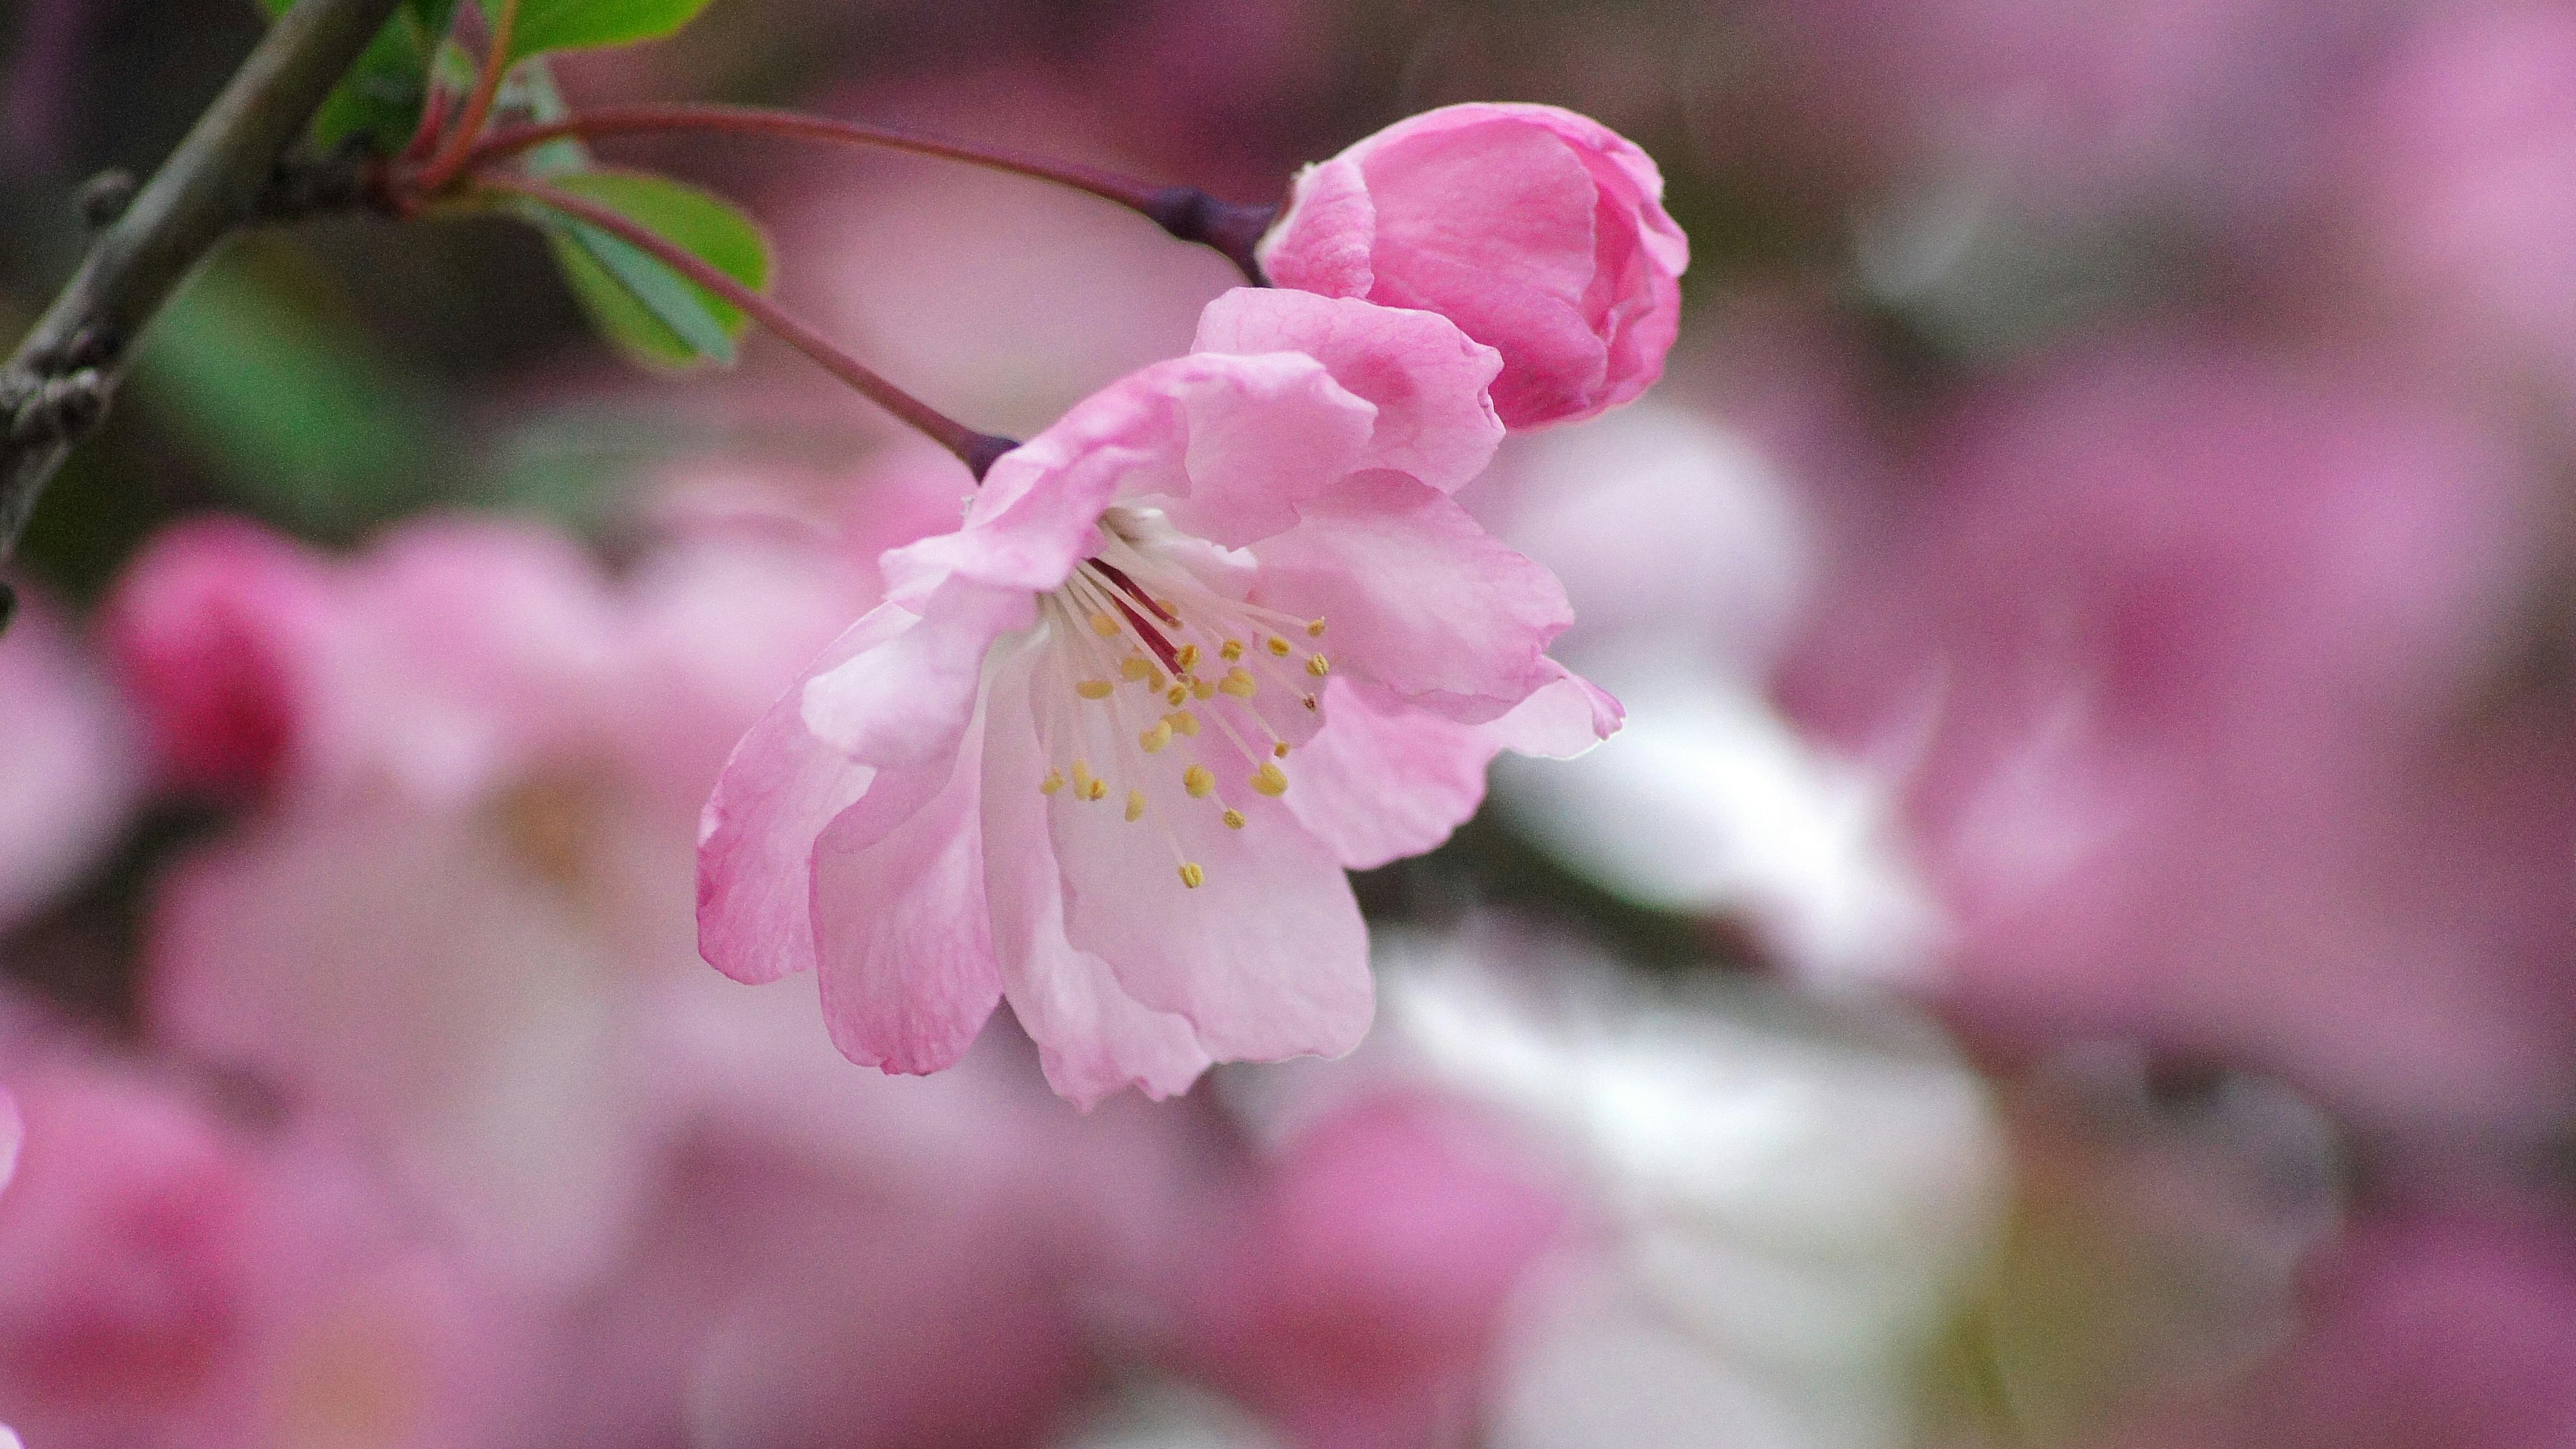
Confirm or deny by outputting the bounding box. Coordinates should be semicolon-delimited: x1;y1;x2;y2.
698;291;1618;1104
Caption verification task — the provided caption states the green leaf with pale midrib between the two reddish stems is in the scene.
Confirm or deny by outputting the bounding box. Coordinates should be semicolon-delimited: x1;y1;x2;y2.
525;170;770;366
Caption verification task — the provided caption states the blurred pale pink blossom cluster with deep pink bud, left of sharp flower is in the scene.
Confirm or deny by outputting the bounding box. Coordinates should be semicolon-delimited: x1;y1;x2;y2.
113;521;885;1279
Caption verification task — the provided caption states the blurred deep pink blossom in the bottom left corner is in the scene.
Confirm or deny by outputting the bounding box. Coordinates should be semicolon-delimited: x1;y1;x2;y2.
0;1046;513;1449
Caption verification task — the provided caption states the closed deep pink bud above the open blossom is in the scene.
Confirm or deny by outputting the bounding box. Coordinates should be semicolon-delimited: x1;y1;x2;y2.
1257;103;1690;428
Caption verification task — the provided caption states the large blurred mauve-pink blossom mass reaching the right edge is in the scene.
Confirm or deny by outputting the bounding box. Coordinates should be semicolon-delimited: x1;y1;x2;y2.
1788;343;2576;1124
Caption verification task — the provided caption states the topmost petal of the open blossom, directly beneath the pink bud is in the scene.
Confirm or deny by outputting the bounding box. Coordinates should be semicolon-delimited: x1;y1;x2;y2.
1193;286;1502;492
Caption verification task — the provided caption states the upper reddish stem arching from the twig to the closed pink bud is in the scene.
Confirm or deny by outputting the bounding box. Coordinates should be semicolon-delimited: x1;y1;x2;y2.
461;103;1278;286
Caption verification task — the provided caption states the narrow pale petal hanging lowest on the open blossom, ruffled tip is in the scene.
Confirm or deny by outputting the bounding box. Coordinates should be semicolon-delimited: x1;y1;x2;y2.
984;637;1214;1109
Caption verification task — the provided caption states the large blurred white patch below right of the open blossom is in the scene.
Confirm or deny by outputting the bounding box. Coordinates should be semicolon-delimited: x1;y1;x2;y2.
1381;938;2006;1449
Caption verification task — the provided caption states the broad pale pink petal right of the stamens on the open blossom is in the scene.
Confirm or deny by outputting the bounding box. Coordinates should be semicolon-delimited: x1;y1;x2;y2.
1252;472;1574;724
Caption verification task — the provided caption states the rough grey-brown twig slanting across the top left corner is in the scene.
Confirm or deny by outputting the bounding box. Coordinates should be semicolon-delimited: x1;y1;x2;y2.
0;0;399;575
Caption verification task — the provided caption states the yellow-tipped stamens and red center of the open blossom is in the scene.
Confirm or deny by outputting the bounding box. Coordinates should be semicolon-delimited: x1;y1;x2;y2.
1030;508;1332;890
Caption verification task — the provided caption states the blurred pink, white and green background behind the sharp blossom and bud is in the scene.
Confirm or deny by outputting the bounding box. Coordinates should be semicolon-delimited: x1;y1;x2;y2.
0;0;2576;1449
